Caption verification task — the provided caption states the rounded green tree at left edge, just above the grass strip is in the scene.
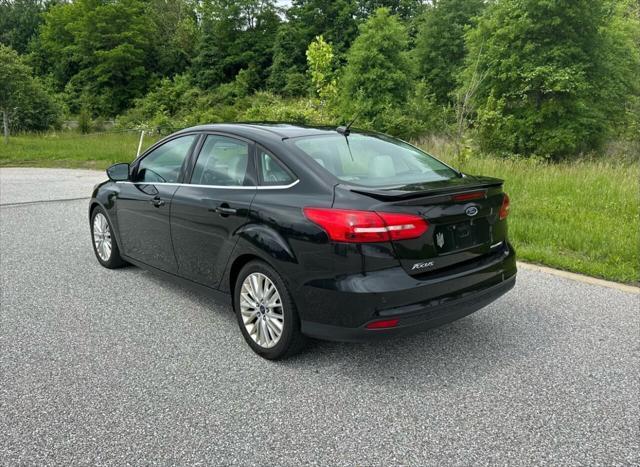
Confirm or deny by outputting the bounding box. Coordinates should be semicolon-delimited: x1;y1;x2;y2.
0;45;59;143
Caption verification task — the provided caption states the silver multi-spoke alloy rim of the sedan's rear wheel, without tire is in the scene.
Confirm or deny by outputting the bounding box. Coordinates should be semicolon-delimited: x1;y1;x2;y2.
240;272;284;348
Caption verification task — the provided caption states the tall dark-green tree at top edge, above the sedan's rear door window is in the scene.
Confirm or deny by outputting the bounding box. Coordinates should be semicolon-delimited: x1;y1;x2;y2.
192;0;280;88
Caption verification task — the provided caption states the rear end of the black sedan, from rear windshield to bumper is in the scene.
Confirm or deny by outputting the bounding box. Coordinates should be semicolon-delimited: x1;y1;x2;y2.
284;131;516;340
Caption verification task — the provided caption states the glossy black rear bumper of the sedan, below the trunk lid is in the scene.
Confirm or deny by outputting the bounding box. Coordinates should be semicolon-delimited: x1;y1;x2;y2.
295;245;516;341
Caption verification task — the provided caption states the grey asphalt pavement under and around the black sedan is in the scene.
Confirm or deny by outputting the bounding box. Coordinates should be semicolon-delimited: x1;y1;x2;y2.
0;169;640;465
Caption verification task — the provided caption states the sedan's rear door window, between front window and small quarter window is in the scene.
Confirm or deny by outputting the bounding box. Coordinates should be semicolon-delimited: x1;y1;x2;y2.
191;135;249;186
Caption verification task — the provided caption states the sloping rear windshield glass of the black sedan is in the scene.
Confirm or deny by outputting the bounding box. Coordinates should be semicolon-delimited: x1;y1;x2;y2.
289;133;457;187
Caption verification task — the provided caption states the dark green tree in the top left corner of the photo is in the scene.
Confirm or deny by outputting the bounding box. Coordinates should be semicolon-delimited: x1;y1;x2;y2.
0;0;46;54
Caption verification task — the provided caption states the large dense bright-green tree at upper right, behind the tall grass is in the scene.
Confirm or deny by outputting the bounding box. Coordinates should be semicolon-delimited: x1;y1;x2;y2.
465;0;637;158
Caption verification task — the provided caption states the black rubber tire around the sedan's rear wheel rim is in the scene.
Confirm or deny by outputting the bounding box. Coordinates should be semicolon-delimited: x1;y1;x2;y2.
233;260;306;360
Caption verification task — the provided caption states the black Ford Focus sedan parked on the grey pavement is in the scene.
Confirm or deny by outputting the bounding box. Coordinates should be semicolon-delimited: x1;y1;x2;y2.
89;124;516;359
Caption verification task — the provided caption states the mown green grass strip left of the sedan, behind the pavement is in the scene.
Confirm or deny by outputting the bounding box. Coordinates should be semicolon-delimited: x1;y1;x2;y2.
0;132;158;169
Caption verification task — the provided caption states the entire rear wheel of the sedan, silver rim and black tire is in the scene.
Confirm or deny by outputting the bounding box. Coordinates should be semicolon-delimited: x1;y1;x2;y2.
234;261;305;360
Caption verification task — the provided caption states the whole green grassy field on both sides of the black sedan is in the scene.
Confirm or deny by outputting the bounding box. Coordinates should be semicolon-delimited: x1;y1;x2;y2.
0;133;640;284
